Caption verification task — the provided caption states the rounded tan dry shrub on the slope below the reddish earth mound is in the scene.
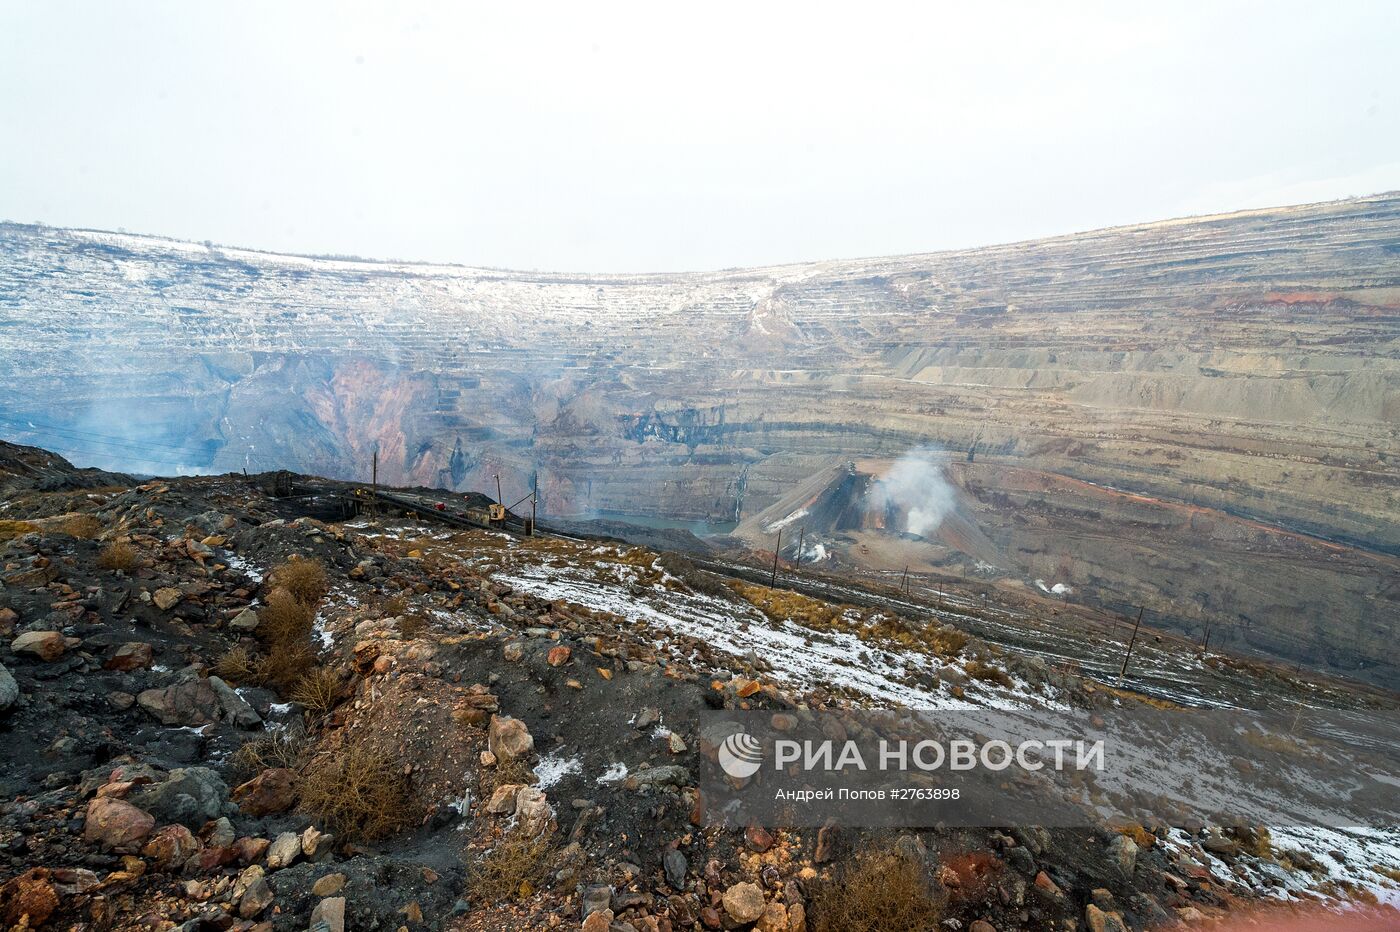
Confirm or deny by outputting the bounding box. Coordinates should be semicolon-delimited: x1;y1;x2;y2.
301;735;417;841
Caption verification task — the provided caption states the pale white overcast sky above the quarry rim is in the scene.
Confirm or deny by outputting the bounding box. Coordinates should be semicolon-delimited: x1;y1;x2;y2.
0;0;1400;271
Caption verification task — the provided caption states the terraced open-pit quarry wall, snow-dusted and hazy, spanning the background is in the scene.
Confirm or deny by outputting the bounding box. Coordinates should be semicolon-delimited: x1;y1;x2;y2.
0;196;1400;674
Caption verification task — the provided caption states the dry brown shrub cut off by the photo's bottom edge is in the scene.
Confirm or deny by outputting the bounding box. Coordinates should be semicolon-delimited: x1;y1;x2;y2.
812;849;942;932
